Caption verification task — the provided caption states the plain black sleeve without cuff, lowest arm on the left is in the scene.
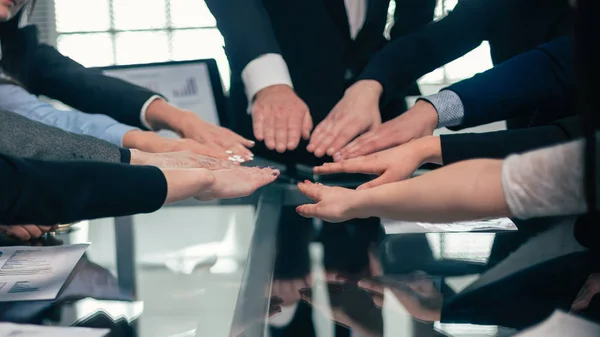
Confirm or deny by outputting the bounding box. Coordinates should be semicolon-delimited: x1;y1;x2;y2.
0;154;167;225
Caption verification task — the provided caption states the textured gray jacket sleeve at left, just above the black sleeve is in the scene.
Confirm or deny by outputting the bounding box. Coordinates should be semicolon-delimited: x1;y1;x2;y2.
0;110;130;163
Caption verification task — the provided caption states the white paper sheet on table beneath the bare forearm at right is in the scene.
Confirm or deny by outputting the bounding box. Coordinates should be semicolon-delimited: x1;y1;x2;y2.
381;218;517;234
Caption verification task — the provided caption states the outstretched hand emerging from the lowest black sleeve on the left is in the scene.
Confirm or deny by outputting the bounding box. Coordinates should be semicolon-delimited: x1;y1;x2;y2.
162;166;279;204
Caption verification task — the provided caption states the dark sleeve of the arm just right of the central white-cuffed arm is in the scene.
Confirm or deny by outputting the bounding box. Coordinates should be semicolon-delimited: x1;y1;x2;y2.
358;0;493;102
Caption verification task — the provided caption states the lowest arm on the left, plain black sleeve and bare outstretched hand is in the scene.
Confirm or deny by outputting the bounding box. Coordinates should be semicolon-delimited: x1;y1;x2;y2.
0;154;279;226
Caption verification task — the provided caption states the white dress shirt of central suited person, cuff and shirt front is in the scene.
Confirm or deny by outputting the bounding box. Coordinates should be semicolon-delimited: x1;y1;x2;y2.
242;0;368;102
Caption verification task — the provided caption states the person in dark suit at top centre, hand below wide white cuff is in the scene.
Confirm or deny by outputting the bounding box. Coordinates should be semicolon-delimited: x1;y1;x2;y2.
206;0;436;167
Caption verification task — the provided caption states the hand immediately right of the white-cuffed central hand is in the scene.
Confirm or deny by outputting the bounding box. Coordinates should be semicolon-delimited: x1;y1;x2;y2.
306;80;383;157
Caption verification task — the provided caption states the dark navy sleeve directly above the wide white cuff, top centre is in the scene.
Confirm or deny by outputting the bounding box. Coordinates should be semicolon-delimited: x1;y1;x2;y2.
206;0;281;74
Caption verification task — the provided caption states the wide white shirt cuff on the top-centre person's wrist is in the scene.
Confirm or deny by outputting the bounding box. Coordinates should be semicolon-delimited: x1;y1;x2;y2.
242;54;293;111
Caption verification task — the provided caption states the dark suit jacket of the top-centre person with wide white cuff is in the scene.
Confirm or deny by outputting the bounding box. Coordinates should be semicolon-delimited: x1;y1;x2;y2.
206;0;435;164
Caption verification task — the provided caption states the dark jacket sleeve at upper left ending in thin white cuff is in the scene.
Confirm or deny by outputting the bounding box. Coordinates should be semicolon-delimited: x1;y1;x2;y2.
0;11;156;128
